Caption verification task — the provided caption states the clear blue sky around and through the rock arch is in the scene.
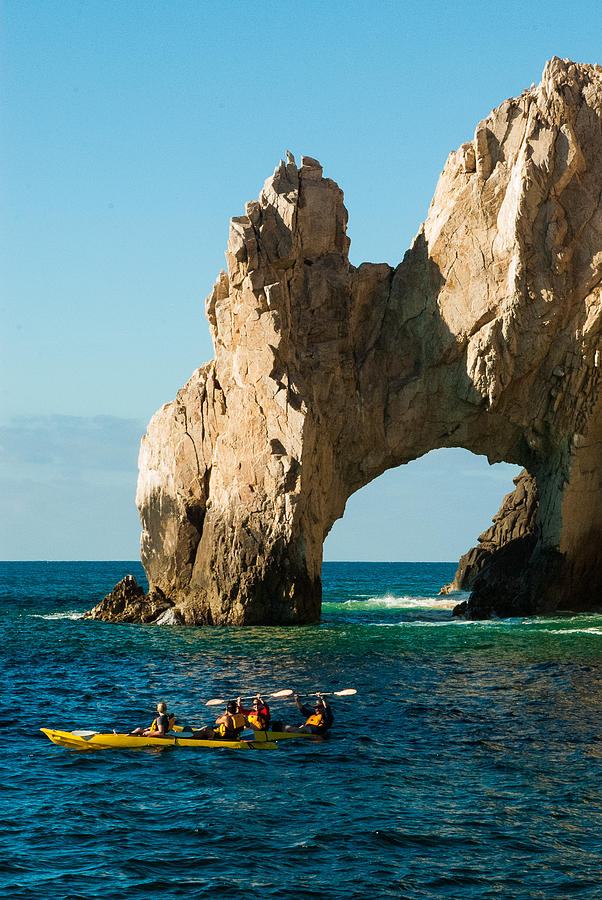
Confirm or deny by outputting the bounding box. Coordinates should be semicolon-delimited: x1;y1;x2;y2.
0;0;600;560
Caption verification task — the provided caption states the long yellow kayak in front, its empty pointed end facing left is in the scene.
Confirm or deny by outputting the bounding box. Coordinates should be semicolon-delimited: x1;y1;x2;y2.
40;728;277;750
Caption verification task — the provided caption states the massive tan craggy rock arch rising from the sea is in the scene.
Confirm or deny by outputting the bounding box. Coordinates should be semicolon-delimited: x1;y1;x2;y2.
90;59;602;624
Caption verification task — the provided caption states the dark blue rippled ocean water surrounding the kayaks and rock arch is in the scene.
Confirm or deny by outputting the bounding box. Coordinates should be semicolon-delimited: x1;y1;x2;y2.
0;562;602;900
